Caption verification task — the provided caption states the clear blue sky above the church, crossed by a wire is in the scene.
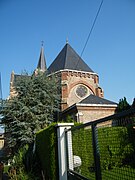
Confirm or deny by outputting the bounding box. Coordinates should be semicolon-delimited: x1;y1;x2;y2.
0;0;135;104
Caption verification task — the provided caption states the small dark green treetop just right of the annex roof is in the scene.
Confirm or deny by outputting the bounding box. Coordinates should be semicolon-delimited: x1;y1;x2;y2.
116;97;131;112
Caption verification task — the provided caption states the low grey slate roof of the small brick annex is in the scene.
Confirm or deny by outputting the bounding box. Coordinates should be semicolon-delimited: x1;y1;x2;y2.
78;94;117;105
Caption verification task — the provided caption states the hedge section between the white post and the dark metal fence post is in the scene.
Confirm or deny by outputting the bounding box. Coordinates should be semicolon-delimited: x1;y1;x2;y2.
72;129;95;179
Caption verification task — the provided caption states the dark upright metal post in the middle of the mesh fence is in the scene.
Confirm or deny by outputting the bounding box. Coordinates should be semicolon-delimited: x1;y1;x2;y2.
92;124;102;180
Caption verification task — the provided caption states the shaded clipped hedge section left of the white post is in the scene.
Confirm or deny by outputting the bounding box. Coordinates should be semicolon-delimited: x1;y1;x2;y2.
36;124;58;180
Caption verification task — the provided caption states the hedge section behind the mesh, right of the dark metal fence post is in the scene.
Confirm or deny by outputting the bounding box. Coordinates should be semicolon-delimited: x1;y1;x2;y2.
98;127;134;170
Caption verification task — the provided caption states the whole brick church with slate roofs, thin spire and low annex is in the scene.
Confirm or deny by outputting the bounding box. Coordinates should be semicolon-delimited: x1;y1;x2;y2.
10;42;117;123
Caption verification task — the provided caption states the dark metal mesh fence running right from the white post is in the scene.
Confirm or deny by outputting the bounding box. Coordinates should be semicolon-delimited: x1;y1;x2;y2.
65;108;135;180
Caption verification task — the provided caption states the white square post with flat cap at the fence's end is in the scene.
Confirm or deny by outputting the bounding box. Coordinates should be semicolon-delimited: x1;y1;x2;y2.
56;123;74;180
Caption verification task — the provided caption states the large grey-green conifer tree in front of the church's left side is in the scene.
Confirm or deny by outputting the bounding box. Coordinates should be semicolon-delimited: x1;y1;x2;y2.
1;73;60;151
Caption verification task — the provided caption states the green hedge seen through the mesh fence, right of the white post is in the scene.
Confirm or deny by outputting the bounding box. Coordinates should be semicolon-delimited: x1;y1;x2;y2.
73;127;135;179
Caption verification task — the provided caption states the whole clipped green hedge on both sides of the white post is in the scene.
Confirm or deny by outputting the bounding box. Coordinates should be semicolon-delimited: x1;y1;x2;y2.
36;124;135;180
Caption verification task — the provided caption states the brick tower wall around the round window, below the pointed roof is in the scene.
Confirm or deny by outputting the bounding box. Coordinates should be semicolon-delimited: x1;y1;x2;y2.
61;70;104;110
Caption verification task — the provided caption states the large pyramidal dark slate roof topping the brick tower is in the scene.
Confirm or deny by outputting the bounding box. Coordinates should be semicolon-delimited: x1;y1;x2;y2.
48;43;93;73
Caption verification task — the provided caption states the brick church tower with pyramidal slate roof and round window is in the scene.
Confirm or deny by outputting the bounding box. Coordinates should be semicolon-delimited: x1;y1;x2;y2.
48;43;103;111
